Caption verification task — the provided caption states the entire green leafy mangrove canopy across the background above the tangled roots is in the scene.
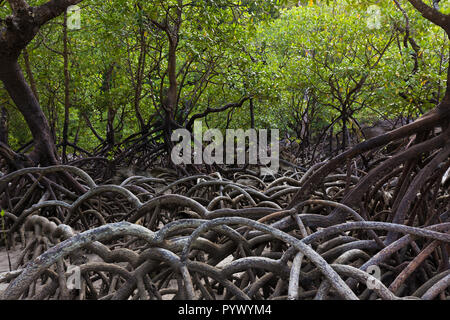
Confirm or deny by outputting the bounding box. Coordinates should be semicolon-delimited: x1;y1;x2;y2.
0;0;450;150
